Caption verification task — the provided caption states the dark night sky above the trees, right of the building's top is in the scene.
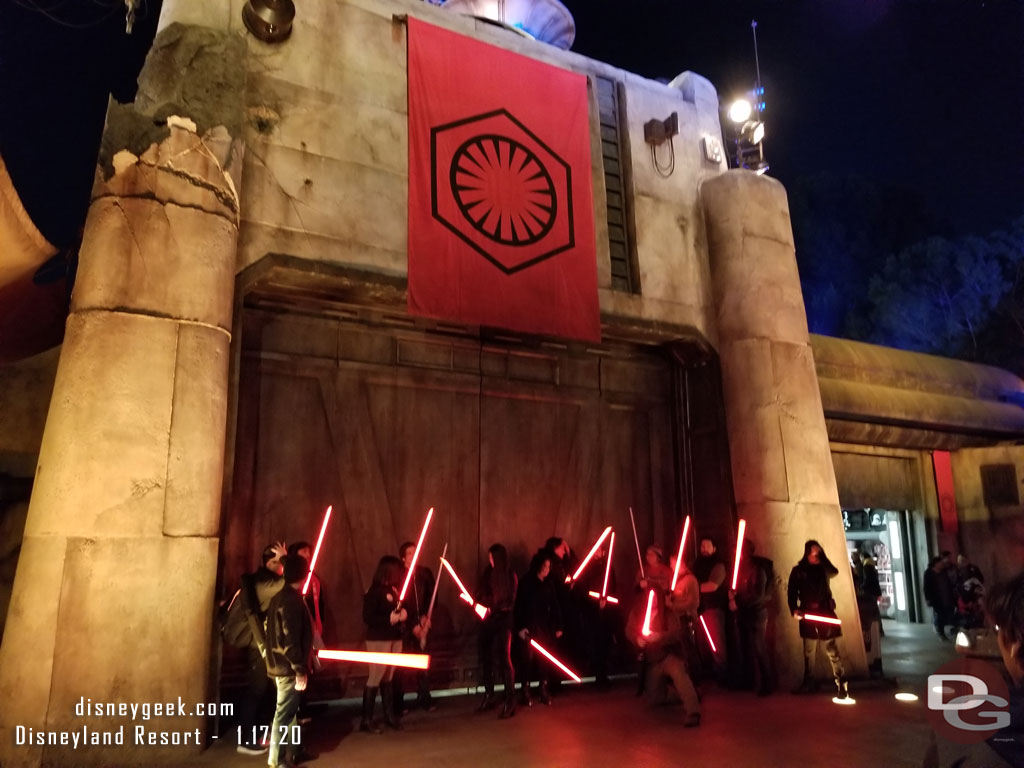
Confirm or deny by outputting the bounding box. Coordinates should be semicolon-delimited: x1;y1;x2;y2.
563;0;1024;236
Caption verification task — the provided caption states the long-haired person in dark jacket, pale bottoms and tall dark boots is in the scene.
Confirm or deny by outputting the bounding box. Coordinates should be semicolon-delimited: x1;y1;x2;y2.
359;555;409;733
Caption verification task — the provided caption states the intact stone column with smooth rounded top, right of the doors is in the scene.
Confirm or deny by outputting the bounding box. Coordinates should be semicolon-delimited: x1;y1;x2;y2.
700;171;866;687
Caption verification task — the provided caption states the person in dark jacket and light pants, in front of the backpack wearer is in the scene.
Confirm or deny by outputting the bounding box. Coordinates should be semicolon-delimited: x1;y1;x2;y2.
266;555;313;766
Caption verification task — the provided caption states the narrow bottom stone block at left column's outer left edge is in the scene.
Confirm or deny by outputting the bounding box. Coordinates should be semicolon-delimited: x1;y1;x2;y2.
0;536;67;766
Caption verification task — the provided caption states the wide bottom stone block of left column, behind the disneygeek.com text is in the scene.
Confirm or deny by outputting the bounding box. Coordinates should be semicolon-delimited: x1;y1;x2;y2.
46;537;217;766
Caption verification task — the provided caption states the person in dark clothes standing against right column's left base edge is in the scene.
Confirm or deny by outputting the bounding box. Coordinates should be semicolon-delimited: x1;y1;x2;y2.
729;539;775;696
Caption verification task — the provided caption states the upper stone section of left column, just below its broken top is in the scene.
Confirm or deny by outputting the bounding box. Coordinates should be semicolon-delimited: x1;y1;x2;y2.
72;198;236;329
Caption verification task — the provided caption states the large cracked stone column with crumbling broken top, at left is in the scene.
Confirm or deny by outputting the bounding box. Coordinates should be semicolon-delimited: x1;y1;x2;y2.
0;12;245;768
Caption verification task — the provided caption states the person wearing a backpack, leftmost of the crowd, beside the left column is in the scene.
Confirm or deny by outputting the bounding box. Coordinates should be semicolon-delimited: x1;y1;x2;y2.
222;543;288;755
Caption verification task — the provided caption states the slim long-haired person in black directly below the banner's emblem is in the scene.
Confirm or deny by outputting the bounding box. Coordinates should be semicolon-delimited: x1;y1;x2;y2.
476;544;517;718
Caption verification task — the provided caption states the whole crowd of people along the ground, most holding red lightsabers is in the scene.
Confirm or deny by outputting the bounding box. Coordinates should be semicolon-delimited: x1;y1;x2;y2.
216;537;1015;766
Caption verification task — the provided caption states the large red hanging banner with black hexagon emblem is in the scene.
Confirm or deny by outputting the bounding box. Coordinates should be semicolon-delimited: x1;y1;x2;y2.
409;17;601;341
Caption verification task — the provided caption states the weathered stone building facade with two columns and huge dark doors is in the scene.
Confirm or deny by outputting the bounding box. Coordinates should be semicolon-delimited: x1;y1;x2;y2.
0;0;1024;767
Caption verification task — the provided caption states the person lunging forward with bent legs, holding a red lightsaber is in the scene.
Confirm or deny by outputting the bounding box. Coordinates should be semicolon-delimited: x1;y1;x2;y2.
626;587;700;728
